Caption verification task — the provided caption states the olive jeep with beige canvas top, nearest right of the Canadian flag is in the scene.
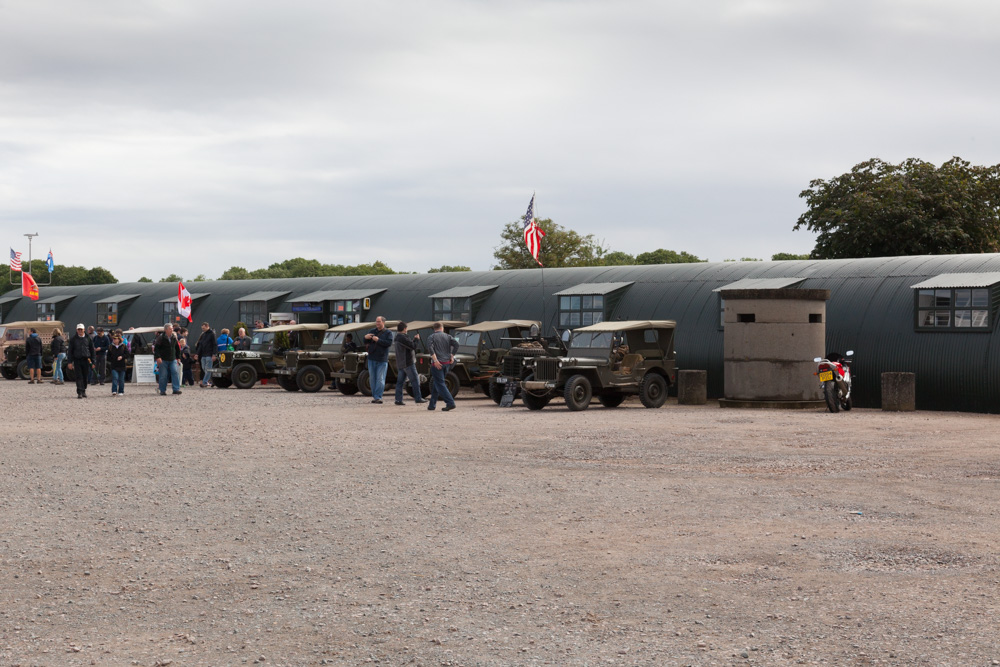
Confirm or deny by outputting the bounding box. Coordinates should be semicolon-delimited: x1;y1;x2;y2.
212;324;327;391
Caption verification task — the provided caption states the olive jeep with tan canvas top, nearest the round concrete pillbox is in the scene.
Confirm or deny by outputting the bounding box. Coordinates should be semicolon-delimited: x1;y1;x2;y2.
521;320;677;411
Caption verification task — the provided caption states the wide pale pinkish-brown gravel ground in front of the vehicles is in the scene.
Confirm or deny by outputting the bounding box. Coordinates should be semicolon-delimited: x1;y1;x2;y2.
0;381;1000;667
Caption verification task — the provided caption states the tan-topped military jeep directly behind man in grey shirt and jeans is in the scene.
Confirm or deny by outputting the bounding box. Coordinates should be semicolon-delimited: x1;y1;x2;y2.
417;320;540;396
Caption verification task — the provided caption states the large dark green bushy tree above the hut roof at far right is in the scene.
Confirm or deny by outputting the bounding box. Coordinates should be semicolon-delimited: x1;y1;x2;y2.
793;157;1000;259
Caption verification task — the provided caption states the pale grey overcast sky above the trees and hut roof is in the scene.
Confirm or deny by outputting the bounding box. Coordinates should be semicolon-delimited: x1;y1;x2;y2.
0;0;1000;282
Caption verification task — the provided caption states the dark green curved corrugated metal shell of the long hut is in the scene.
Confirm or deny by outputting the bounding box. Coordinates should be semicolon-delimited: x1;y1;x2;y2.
4;254;1000;412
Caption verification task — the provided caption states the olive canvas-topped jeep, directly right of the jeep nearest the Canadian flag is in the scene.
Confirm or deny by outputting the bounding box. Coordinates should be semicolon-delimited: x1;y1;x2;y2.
276;322;398;396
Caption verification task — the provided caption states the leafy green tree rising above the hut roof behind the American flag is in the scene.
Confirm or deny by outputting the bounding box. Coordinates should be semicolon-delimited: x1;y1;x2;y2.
493;218;608;269
